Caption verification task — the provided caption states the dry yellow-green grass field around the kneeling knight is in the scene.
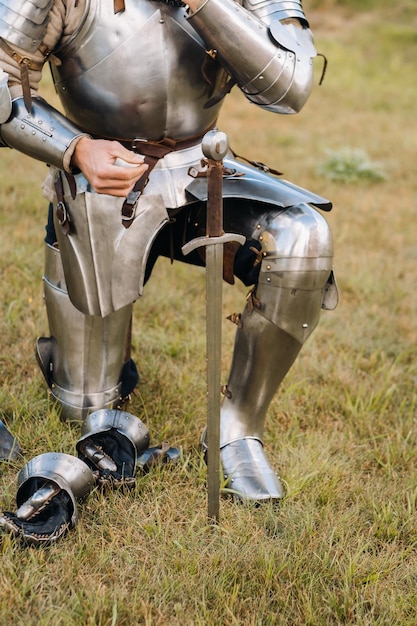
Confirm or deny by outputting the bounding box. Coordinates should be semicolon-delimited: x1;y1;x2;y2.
0;0;417;626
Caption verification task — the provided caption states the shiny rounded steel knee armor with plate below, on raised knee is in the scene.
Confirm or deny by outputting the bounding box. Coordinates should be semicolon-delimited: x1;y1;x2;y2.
253;204;337;343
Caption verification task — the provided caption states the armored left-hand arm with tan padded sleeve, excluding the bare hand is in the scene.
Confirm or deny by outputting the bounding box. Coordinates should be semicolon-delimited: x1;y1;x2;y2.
0;0;85;170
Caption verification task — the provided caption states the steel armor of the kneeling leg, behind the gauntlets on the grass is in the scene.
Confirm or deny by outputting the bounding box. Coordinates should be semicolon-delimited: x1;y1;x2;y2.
37;244;137;421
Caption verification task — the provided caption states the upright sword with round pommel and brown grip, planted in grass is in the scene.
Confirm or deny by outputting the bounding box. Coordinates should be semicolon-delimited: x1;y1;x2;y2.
182;128;245;522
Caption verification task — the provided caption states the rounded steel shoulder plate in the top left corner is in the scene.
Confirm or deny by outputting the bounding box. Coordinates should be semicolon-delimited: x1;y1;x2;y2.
0;0;54;54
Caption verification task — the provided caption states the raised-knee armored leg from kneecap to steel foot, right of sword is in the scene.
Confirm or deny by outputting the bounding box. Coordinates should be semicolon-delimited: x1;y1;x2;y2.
220;205;333;501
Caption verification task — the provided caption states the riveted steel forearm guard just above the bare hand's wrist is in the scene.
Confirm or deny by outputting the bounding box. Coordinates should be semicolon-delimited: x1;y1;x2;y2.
0;97;85;169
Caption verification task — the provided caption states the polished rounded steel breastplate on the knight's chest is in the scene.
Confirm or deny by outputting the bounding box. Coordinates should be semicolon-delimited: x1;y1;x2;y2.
52;0;223;140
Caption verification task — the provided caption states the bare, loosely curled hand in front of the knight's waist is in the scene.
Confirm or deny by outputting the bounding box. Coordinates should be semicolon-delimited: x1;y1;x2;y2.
71;137;148;198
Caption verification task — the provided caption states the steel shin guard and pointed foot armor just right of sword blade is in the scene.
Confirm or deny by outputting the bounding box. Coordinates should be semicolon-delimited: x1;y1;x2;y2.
220;308;301;501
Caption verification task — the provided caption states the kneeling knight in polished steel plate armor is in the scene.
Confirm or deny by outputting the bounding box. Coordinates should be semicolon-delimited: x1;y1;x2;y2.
0;0;337;540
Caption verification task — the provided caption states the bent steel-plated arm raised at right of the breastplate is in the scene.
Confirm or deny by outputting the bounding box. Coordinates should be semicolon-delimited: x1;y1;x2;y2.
189;0;316;113
